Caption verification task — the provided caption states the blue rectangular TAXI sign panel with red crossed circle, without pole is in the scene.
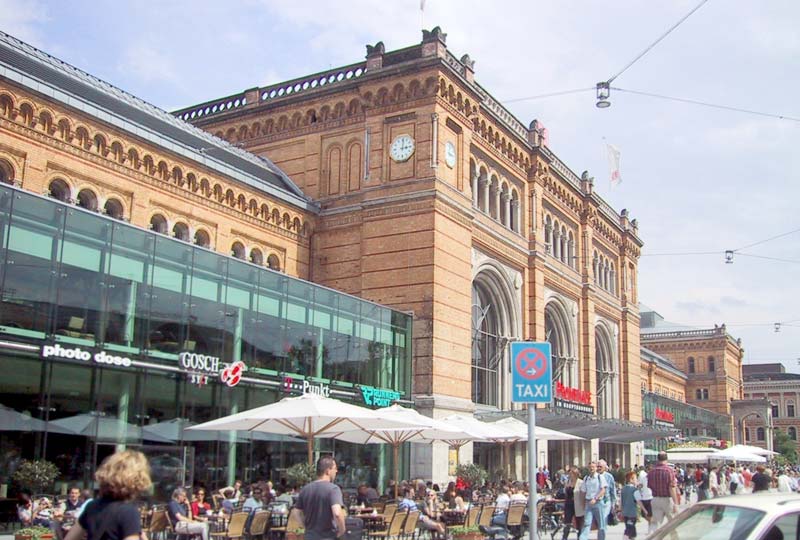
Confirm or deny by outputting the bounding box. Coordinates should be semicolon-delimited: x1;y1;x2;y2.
511;341;553;403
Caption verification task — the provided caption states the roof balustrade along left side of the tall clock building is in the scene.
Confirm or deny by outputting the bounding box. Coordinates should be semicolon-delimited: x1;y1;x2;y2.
174;62;367;121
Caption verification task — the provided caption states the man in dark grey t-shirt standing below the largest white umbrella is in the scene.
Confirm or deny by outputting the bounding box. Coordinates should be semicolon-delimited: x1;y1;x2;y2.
292;456;345;540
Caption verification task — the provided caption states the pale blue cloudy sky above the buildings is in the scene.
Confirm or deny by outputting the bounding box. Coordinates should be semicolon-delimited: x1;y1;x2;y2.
0;0;800;372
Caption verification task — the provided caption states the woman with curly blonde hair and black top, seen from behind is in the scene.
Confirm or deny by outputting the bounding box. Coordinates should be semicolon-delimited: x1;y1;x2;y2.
65;450;152;540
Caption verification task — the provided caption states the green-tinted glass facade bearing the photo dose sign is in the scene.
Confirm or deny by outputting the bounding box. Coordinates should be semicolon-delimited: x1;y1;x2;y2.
0;186;411;498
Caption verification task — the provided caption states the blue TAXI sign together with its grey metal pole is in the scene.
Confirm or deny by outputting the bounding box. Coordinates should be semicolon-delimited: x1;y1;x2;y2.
511;341;553;540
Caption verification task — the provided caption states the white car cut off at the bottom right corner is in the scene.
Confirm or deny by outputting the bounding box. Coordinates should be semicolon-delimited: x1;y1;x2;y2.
648;492;800;540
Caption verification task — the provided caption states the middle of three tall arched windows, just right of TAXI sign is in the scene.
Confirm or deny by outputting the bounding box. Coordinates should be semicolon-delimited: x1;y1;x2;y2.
544;300;579;388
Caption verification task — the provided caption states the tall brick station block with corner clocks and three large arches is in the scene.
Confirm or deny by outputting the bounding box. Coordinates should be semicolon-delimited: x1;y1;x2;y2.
180;27;664;477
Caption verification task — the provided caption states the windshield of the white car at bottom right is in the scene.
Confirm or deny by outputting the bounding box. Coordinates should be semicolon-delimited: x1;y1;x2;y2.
650;504;764;540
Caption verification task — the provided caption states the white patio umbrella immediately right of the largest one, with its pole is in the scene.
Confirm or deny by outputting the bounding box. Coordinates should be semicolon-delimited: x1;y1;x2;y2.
335;405;472;498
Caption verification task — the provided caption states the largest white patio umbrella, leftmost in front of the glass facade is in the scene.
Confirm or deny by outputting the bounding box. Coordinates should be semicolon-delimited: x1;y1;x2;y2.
188;394;420;465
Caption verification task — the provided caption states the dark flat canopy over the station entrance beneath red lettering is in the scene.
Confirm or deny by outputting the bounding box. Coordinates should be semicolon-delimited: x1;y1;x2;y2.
478;408;678;444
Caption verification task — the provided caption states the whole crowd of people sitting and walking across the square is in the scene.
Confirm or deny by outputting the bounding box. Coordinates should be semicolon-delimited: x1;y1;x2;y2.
18;451;800;540
